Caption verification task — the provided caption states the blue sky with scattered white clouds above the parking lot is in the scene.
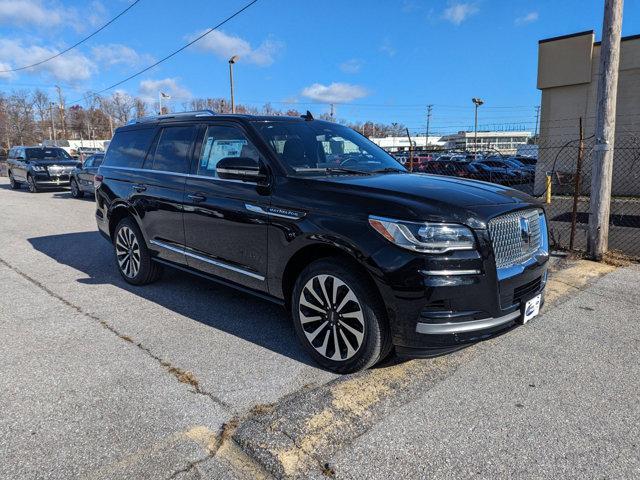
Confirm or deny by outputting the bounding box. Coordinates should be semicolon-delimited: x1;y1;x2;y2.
0;0;640;133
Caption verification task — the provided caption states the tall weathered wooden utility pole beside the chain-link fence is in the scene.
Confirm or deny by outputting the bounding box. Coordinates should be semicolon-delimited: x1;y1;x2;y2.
588;0;624;260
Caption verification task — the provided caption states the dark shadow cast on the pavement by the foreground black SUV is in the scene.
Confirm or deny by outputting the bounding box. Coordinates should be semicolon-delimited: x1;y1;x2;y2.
28;231;317;366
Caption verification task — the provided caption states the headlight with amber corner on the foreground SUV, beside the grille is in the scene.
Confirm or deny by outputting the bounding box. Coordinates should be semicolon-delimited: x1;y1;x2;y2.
369;216;475;253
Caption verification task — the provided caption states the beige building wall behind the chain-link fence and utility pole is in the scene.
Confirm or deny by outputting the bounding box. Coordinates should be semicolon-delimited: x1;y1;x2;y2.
535;32;640;195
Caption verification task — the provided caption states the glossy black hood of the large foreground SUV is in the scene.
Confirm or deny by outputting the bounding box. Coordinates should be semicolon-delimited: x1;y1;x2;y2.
322;173;537;208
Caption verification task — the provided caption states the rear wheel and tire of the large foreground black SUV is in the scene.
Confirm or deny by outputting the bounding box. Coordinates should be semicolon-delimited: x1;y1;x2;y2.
113;217;162;285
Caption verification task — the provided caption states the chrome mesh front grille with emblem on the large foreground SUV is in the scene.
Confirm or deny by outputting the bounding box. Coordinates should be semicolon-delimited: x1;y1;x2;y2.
489;210;542;268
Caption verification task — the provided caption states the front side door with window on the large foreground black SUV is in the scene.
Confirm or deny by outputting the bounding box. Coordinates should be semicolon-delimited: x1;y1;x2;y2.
184;125;270;291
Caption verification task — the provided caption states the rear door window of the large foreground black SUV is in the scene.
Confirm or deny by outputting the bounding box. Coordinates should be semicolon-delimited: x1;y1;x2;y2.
145;125;196;173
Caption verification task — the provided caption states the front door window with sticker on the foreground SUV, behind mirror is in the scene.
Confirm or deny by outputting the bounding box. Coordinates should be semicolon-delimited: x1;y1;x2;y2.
198;125;260;177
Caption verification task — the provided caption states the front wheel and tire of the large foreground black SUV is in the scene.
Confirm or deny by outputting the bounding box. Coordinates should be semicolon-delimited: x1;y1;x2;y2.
291;258;392;373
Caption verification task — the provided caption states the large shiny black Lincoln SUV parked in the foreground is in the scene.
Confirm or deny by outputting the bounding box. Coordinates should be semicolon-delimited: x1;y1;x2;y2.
95;111;549;372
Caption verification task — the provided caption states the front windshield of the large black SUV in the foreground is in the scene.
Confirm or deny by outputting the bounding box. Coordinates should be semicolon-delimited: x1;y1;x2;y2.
256;121;406;175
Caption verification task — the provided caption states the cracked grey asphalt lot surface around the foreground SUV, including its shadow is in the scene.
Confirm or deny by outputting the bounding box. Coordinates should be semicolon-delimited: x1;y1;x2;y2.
0;178;640;480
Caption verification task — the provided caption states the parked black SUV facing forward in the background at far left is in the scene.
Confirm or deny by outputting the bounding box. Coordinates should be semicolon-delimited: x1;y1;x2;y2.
7;146;78;193
